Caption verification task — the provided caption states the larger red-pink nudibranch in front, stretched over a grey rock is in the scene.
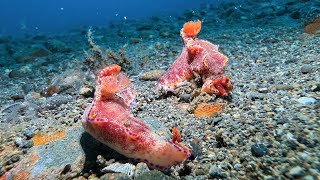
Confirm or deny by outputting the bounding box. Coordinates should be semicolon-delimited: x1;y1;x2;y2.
82;65;191;170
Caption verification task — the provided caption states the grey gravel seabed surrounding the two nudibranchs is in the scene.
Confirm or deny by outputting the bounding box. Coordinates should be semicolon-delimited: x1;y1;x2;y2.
0;1;320;179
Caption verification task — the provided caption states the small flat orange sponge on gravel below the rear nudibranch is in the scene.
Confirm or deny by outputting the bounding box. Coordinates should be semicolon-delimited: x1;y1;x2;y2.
193;103;223;118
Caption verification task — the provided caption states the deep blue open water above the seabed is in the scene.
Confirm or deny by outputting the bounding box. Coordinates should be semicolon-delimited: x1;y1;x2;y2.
0;0;215;35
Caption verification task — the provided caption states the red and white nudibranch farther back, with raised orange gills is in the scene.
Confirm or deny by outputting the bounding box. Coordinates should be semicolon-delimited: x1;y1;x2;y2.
156;20;232;96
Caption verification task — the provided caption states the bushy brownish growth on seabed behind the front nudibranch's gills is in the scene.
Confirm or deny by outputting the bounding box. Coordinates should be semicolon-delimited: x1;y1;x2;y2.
83;29;131;76
